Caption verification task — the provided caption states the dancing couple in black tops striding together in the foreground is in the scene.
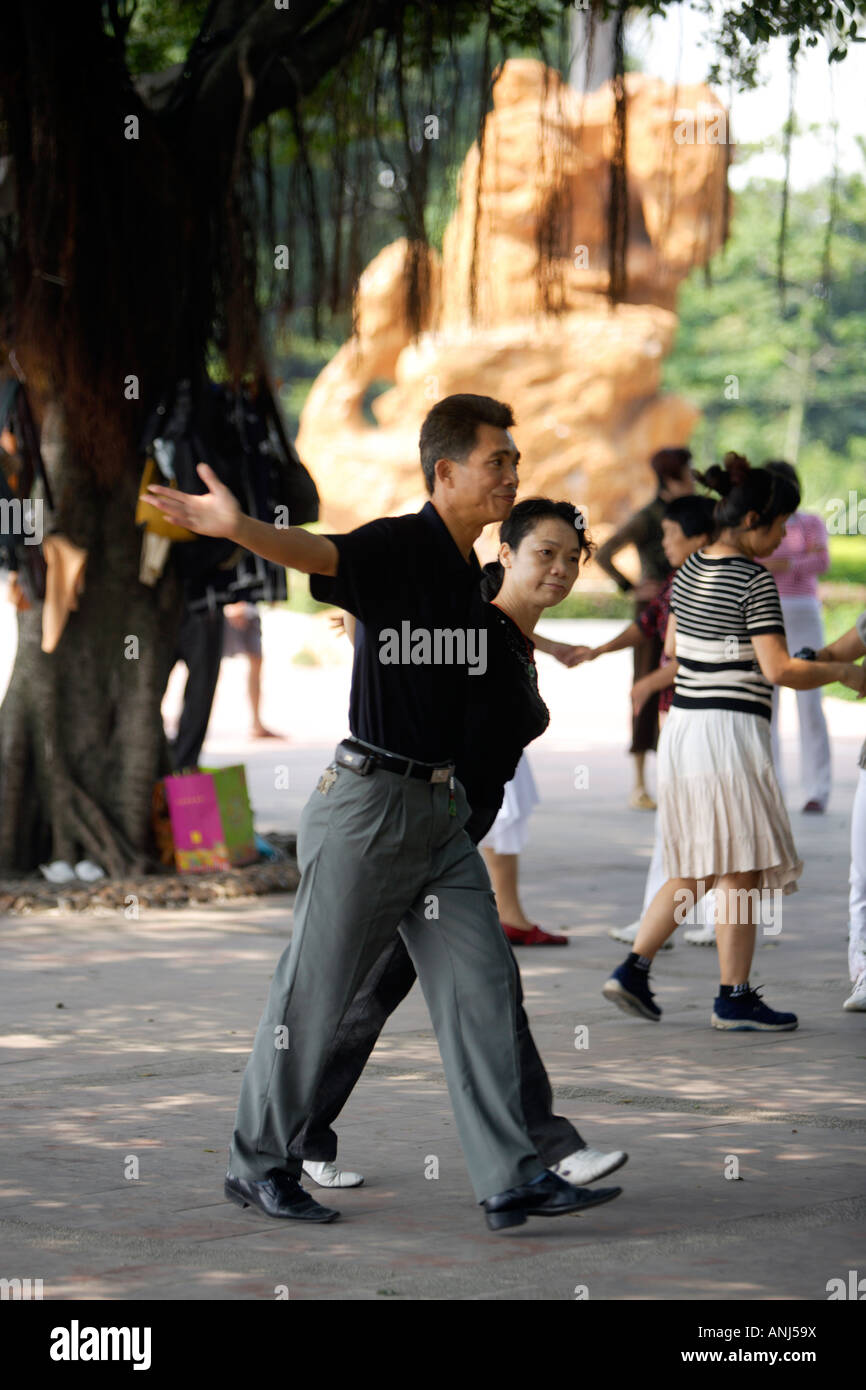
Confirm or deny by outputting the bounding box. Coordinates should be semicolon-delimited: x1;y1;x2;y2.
149;395;626;1230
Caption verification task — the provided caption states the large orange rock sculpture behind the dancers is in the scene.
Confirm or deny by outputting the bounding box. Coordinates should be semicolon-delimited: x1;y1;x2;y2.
297;58;728;537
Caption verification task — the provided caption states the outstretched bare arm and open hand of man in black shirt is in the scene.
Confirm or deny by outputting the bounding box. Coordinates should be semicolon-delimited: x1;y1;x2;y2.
143;463;339;574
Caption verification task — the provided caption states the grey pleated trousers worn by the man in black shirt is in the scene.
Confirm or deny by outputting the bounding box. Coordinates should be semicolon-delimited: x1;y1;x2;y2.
229;767;544;1201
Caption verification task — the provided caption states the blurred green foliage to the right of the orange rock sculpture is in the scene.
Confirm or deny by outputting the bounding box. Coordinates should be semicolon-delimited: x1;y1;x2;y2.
663;163;866;507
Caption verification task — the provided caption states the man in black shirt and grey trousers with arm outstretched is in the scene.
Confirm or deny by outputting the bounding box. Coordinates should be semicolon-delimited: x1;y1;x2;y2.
149;396;620;1230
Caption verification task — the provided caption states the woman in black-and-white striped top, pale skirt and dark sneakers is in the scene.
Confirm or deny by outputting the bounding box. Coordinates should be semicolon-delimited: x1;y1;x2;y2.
603;455;866;1031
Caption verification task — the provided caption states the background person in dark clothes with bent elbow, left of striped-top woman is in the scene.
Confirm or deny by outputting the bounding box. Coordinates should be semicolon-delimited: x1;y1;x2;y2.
596;449;695;810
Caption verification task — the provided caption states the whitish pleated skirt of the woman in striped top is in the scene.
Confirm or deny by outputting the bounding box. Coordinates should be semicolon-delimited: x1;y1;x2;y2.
657;706;803;892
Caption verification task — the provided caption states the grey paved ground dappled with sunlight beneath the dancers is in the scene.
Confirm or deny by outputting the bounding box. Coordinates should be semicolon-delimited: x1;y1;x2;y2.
0;614;866;1301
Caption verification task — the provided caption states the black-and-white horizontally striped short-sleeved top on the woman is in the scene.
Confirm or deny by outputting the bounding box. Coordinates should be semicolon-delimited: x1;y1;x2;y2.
670;550;785;719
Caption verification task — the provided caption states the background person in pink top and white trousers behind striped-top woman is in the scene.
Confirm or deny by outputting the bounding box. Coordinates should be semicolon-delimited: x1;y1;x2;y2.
763;459;833;815
